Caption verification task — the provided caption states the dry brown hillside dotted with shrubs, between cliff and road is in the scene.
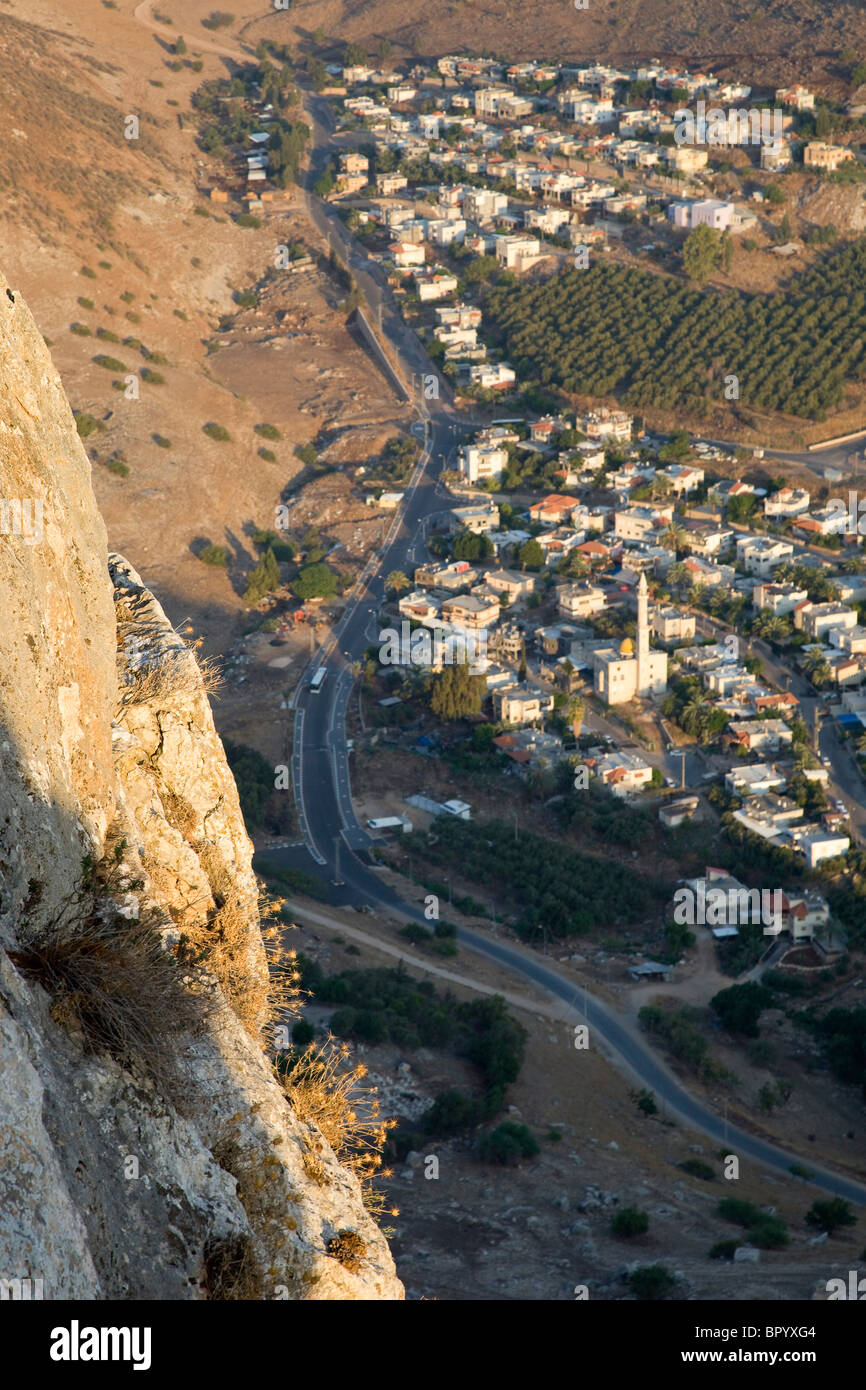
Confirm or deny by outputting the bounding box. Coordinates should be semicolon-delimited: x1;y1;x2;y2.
0;0;400;653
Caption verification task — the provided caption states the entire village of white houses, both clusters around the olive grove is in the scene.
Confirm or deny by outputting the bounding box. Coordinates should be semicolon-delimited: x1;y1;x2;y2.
184;46;866;978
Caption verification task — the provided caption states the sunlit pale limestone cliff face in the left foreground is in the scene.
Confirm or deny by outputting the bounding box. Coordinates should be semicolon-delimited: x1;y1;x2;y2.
0;278;403;1300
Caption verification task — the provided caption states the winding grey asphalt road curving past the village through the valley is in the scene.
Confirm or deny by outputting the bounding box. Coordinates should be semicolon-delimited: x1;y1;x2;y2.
127;16;866;1205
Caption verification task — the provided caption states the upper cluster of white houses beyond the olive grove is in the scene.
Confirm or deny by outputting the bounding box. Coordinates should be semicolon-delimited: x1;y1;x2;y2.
309;57;859;305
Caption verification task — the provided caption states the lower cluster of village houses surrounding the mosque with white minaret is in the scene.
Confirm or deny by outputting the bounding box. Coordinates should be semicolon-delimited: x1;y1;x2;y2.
348;386;866;969
